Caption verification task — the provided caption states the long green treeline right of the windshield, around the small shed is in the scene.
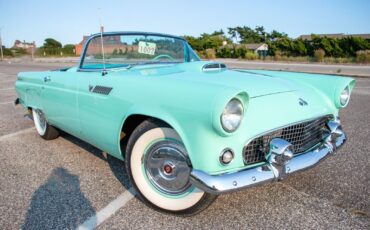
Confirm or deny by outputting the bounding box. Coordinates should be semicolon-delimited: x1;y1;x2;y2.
185;26;370;60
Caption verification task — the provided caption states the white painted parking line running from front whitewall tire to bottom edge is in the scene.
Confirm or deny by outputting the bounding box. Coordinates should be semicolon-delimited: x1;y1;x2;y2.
77;188;135;230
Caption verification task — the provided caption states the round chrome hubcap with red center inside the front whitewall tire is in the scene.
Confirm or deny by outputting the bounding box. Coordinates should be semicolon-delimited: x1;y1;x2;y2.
143;140;191;195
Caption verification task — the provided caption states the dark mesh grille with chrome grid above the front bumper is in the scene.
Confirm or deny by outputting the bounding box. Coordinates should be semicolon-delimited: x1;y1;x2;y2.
243;115;333;165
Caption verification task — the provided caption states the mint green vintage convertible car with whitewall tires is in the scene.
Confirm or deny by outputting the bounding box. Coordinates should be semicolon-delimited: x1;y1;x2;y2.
16;32;355;215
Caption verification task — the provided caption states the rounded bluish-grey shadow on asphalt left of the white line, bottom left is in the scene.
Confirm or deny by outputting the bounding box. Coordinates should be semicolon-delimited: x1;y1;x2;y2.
22;167;95;229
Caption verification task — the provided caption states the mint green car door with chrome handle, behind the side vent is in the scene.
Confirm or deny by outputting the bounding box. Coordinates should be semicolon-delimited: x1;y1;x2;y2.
41;71;80;136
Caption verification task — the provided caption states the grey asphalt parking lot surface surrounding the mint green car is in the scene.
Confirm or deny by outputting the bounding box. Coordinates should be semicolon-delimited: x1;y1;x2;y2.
0;63;370;229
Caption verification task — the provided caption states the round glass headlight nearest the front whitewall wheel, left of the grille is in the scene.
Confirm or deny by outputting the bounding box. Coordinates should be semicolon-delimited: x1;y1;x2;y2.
221;98;244;133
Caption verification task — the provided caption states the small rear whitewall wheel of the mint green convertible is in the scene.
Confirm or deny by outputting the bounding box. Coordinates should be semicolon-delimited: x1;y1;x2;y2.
32;109;59;140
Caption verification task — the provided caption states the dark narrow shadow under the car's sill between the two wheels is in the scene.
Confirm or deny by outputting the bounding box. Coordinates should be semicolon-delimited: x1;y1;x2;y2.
61;132;132;191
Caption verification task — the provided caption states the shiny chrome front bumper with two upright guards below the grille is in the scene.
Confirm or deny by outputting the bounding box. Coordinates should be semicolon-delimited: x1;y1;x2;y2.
190;120;346;194
